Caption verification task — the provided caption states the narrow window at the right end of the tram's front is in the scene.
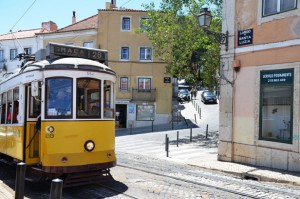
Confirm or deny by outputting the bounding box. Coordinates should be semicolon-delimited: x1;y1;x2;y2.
104;80;114;118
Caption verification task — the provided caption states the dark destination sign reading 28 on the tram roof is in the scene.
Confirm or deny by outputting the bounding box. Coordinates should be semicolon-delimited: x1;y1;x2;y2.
46;43;108;65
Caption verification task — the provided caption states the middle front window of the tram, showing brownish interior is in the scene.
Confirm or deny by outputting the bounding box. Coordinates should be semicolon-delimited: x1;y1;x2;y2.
76;78;101;118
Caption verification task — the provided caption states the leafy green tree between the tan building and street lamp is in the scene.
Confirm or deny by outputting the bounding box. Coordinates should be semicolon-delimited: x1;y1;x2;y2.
141;0;222;88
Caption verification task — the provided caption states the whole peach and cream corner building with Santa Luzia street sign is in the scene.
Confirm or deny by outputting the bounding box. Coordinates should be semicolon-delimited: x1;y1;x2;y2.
218;0;300;171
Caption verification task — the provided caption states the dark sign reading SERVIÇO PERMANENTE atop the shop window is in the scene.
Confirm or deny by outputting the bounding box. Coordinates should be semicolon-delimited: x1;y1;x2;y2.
260;68;294;84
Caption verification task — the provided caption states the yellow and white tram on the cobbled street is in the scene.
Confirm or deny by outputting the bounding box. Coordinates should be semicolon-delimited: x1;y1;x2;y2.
0;43;116;187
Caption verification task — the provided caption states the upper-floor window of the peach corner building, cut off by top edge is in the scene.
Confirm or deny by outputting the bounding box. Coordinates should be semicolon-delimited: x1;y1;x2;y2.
263;0;297;16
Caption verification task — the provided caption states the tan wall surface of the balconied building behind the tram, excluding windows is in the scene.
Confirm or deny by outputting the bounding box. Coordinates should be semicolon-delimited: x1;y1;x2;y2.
98;9;172;127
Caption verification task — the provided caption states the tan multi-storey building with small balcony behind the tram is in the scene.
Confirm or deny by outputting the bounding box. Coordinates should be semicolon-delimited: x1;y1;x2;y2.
97;1;172;128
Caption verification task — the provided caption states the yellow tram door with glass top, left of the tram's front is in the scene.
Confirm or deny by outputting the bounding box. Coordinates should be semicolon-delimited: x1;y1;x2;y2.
25;85;41;163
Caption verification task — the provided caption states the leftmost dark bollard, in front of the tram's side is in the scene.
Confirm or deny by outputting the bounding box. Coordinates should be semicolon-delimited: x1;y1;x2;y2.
15;162;26;199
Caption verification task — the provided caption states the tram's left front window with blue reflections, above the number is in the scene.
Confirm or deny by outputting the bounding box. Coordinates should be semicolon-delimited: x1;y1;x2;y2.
46;77;73;118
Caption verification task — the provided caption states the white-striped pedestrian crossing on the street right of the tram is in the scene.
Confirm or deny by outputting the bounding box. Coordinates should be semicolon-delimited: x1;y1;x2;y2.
116;136;217;163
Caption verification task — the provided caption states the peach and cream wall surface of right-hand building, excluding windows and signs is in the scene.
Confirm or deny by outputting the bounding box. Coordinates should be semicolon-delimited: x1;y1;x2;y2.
218;0;300;171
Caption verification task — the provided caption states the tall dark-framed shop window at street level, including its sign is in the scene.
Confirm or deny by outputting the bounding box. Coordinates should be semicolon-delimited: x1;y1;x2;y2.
259;69;294;143
